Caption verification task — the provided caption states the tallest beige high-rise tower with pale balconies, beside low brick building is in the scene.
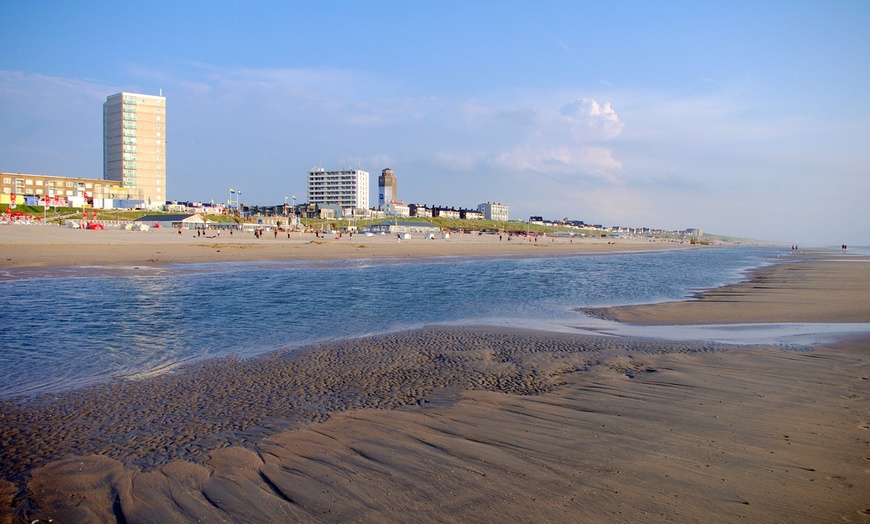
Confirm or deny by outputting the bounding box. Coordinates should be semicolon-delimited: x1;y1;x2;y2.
103;92;166;207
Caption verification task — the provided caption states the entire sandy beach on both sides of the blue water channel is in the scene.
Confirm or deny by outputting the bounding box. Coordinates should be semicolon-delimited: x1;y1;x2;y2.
0;227;870;523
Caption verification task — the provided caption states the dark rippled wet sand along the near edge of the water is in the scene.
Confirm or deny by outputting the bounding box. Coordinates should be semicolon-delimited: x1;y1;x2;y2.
0;328;717;480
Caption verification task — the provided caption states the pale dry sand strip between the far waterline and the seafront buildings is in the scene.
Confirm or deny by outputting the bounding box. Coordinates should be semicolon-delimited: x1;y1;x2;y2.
0;225;689;270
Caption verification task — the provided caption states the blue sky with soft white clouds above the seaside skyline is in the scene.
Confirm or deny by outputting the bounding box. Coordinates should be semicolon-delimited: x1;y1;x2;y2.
0;0;870;246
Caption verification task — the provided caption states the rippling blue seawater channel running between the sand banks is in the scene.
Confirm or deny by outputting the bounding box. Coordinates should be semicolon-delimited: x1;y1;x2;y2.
0;247;870;399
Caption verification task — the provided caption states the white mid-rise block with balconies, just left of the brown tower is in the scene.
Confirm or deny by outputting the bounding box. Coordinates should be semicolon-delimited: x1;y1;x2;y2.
308;168;369;216
